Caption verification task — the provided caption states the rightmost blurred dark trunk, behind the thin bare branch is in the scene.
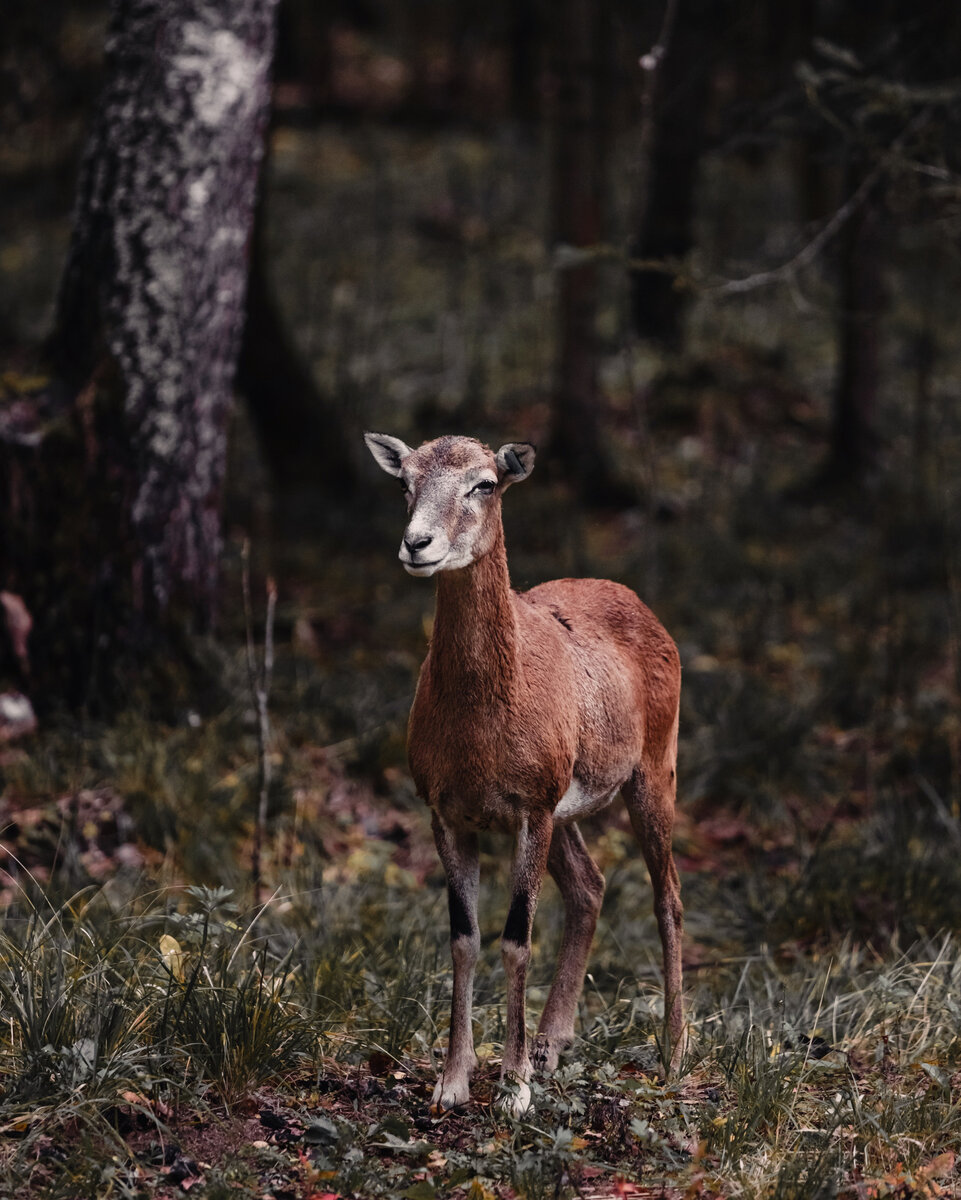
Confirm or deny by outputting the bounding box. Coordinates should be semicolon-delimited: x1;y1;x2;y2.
827;172;885;482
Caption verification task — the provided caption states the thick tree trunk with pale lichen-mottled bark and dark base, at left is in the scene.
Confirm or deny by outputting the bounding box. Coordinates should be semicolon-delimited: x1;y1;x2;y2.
6;0;276;701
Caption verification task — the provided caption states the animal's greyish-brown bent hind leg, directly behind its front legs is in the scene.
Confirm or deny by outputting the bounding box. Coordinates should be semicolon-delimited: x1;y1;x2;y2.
533;824;603;1070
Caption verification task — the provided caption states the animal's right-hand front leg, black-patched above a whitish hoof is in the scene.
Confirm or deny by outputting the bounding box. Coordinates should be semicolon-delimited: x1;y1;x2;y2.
500;811;553;1116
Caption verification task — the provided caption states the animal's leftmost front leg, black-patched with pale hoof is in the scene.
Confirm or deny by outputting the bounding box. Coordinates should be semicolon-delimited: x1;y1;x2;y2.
431;815;480;1116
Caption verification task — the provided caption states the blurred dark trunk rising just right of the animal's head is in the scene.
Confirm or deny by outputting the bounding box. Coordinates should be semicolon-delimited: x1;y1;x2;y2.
551;0;617;503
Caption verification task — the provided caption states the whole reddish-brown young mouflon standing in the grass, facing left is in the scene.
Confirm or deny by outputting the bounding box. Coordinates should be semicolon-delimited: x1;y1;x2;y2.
365;433;684;1114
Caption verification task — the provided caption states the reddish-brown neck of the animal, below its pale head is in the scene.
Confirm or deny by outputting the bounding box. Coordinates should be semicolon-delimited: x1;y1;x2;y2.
431;527;517;704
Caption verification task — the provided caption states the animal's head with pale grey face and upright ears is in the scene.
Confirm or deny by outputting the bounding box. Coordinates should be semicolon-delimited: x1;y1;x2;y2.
364;433;534;576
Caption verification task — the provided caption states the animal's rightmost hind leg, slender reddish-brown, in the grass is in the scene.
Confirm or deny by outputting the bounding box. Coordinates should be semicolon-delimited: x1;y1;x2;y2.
623;751;684;1070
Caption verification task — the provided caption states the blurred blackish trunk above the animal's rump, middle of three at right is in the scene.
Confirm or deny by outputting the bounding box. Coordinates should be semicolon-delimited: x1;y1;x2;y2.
631;0;717;349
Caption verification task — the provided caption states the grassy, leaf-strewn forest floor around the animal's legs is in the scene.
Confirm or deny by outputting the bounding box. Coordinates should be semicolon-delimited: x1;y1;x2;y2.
0;744;961;1200
